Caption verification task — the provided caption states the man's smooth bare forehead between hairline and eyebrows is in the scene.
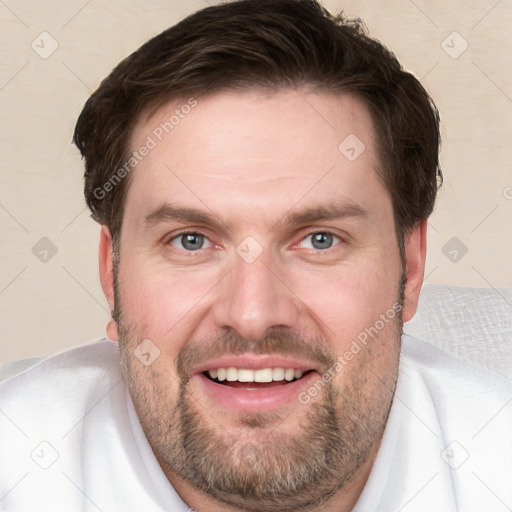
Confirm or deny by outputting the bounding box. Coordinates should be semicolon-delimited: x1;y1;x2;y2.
125;90;389;228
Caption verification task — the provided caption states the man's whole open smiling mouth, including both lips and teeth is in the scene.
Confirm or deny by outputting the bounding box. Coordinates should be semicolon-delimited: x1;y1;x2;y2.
193;356;319;413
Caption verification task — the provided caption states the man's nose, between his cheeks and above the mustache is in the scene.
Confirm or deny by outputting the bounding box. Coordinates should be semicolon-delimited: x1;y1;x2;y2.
213;249;300;339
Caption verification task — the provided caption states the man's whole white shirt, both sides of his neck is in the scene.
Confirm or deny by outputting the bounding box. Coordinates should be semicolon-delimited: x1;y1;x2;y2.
0;335;512;512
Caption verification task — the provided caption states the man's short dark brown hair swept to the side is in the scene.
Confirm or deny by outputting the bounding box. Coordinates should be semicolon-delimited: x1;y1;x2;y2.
73;0;441;248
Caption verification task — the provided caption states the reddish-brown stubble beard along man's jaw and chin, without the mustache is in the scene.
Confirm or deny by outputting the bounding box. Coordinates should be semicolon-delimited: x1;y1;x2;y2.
118;315;402;512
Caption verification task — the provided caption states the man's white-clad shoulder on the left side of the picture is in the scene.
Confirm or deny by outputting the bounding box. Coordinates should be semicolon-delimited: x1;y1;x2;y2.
0;340;179;512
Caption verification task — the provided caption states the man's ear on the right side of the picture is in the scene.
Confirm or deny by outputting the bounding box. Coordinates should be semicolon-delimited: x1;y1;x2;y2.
402;219;427;322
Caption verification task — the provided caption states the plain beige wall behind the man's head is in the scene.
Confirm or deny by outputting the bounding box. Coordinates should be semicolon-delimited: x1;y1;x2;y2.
0;0;512;363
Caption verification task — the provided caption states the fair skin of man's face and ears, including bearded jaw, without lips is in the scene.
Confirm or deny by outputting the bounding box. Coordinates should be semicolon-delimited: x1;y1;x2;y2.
99;90;426;512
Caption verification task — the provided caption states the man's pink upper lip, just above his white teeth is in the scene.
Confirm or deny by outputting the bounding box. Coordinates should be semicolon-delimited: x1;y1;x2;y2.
192;354;316;374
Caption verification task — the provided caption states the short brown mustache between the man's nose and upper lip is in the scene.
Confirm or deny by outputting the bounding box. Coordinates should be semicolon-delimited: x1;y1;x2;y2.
176;327;336;382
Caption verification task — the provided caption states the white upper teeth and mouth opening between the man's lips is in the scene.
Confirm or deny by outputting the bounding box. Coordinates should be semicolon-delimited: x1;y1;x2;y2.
203;367;313;391
